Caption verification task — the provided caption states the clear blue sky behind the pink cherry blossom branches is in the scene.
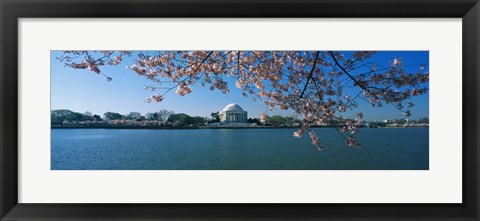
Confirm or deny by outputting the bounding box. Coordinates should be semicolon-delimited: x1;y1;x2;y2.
50;51;429;121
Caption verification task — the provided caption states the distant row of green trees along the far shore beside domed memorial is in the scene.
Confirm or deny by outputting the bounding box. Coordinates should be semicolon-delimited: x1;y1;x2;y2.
51;109;429;128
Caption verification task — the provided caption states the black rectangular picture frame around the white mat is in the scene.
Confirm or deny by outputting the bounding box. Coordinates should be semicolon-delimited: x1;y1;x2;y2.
0;0;480;221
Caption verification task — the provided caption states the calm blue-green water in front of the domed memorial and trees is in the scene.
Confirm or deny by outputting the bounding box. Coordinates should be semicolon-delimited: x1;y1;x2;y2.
51;128;428;170
